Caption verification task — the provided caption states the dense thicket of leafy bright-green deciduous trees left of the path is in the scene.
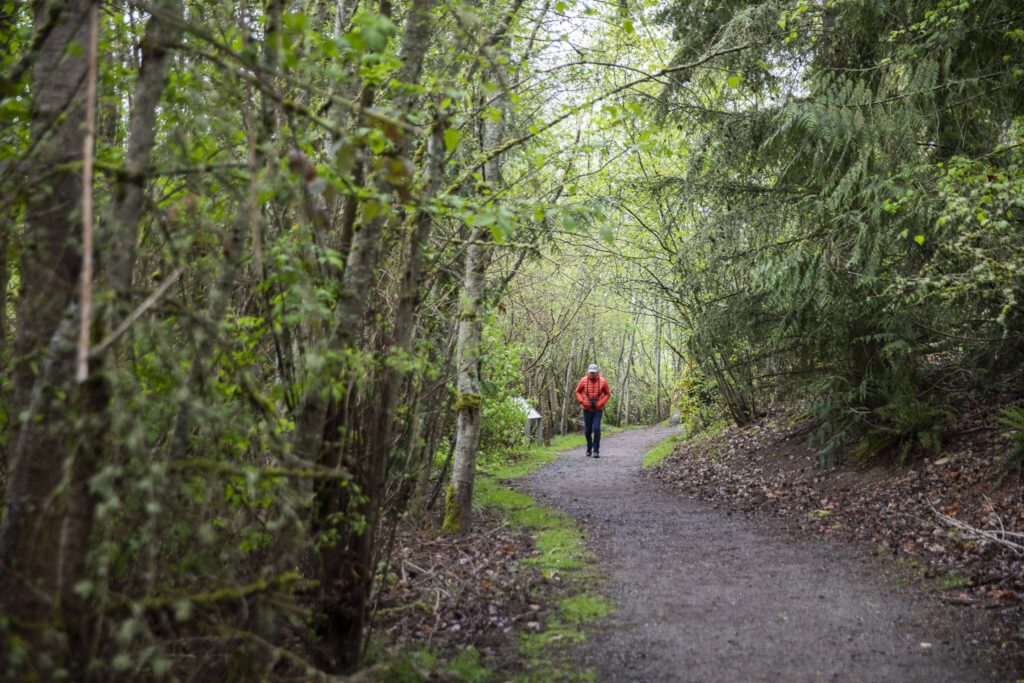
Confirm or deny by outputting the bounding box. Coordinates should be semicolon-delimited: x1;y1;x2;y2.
0;0;622;680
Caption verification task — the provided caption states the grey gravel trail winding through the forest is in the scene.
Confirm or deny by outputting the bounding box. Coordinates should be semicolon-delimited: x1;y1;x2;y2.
517;427;1013;683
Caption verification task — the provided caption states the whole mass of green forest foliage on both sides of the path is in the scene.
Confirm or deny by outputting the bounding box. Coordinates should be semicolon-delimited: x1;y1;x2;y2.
6;0;1024;680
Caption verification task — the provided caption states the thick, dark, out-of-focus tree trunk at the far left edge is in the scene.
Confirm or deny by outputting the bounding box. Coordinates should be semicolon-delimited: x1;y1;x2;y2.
0;0;92;666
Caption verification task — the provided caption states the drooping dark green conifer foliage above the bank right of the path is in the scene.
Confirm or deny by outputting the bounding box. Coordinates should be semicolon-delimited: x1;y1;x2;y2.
636;0;1024;462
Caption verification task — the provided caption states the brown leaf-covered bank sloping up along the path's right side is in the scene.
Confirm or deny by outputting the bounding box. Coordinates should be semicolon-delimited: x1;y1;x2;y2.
647;409;1024;650
